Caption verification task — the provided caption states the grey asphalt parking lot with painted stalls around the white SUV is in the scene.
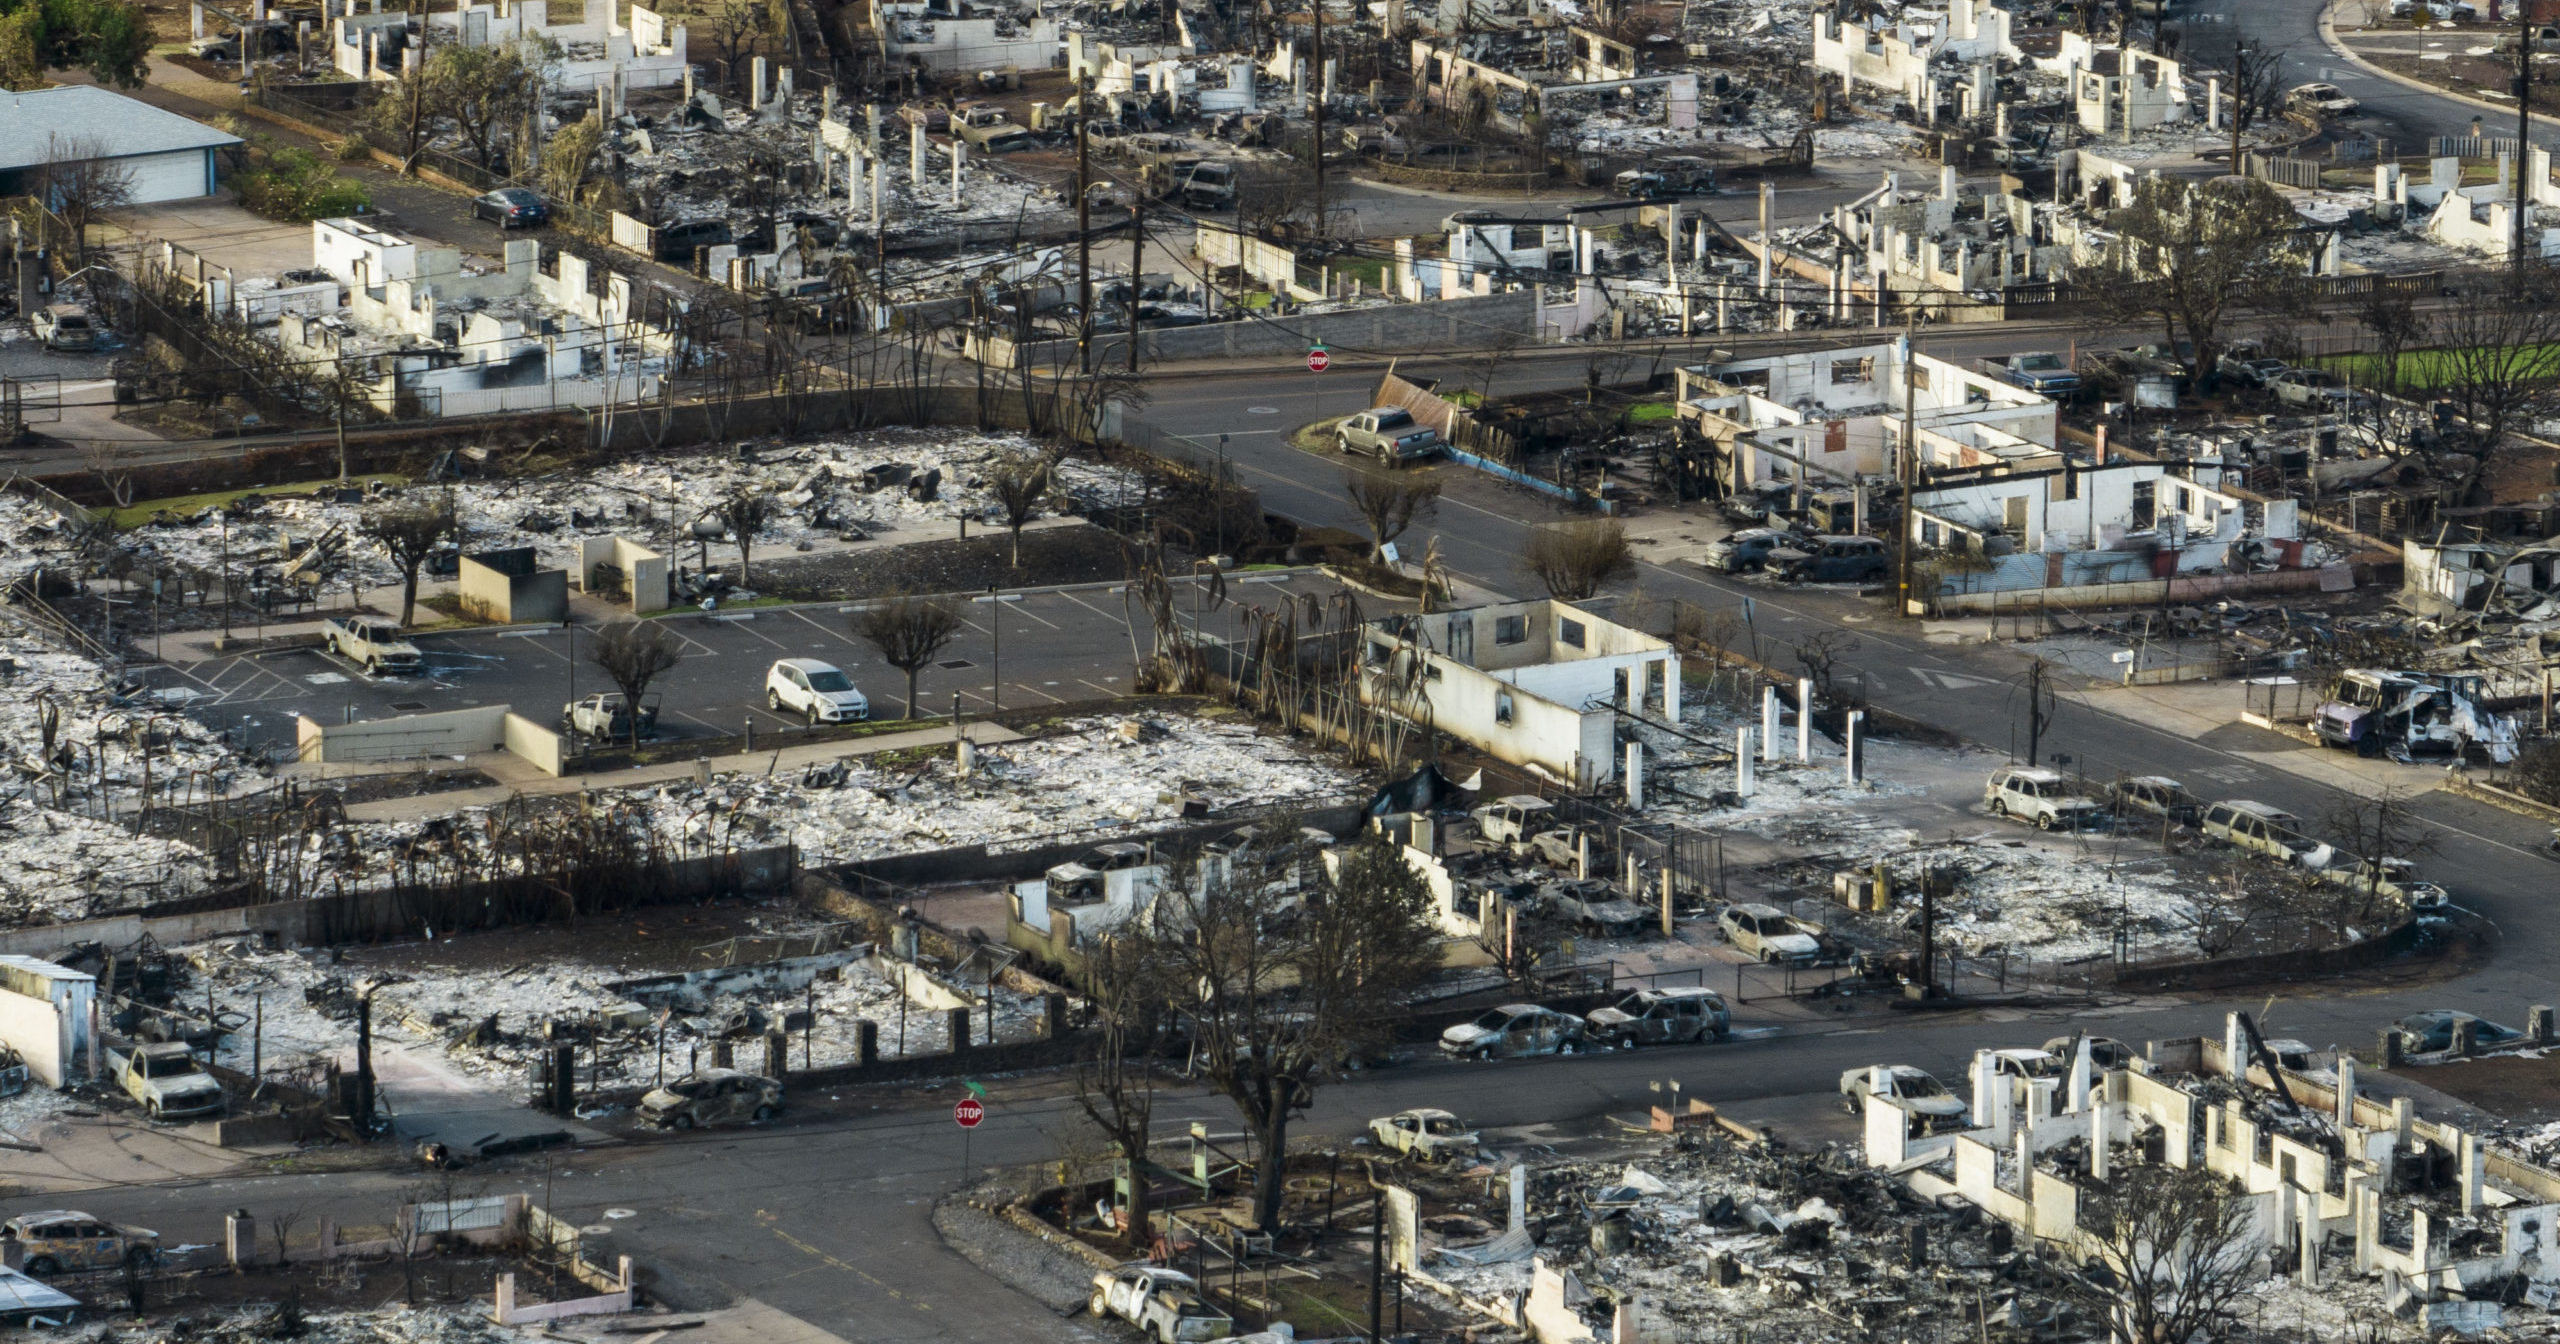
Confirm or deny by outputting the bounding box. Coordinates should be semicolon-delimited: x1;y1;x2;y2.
151;571;1336;748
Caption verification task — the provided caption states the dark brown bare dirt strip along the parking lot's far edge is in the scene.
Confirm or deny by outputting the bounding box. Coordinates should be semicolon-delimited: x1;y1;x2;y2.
755;525;1129;602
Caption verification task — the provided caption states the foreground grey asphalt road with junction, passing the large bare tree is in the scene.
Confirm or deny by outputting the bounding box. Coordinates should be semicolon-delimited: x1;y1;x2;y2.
35;983;2519;1344
